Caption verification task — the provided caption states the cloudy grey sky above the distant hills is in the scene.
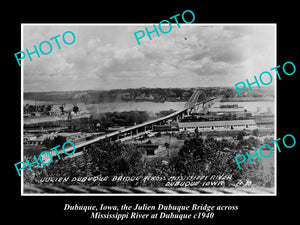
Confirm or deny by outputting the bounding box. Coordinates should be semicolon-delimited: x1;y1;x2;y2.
21;23;276;92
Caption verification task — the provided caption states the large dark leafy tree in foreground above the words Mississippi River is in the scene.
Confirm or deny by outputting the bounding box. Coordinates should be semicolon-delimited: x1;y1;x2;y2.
170;138;247;186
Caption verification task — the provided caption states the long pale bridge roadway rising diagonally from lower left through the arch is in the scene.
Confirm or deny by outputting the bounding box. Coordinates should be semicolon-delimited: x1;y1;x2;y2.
61;96;220;156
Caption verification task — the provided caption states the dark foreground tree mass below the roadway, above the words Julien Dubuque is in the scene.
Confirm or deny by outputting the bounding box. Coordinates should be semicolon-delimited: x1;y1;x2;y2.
24;139;143;186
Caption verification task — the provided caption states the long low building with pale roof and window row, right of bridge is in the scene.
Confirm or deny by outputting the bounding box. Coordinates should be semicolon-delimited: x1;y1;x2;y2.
178;120;258;132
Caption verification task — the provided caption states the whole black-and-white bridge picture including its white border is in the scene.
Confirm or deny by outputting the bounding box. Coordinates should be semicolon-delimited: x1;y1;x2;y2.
21;23;276;196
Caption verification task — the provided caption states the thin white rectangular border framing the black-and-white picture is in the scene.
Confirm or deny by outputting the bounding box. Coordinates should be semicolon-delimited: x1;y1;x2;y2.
20;23;277;197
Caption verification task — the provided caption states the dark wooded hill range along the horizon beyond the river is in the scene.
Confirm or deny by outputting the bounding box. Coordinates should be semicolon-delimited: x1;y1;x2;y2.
24;87;274;104
